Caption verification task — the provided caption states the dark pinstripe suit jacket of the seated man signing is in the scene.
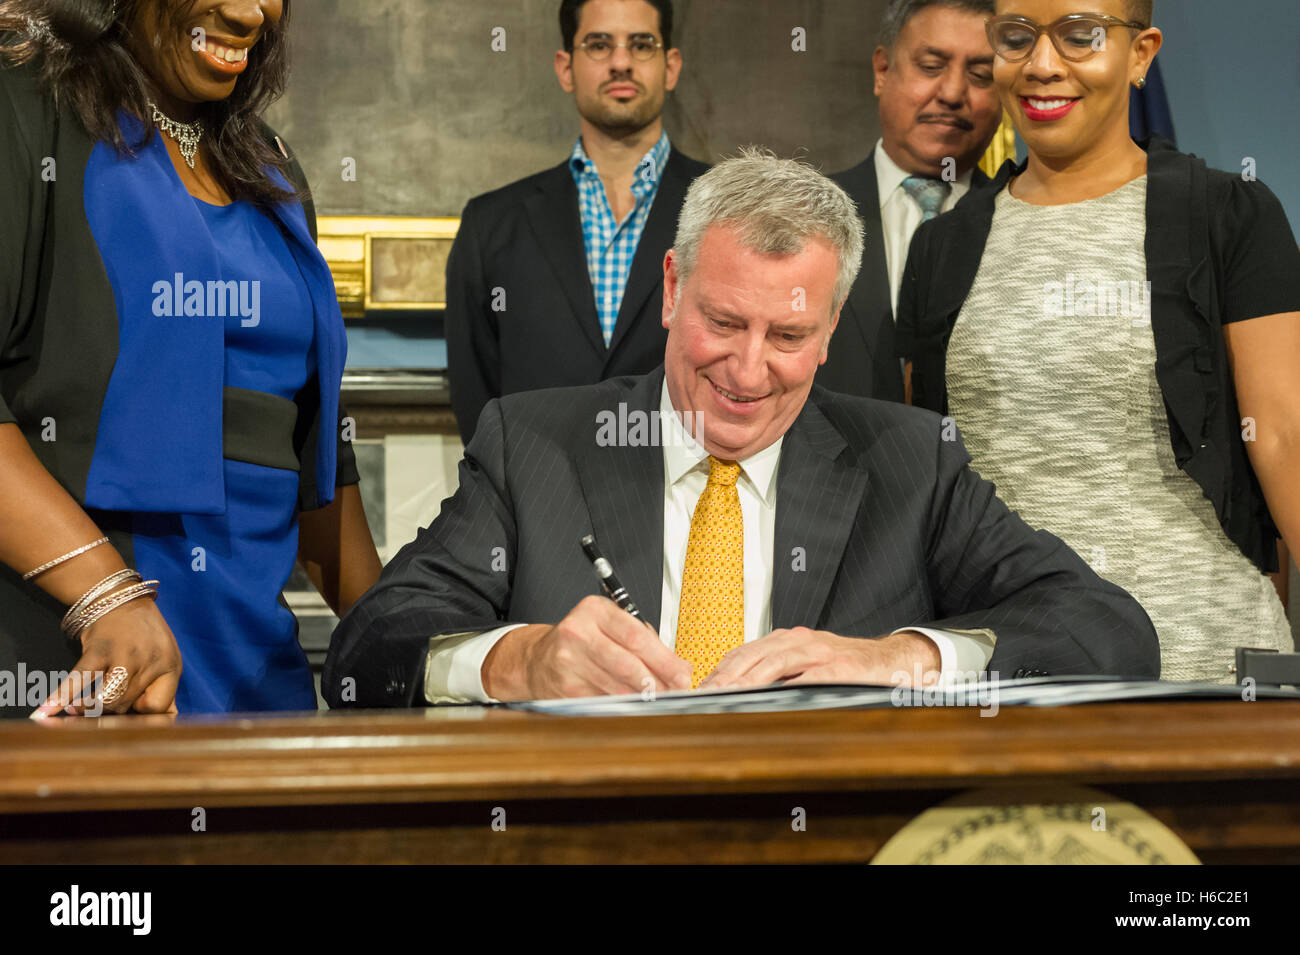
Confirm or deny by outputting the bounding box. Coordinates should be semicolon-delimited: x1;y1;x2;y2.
322;368;1160;707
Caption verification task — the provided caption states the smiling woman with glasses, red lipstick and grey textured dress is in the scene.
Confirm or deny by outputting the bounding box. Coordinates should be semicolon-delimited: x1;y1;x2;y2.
898;0;1300;681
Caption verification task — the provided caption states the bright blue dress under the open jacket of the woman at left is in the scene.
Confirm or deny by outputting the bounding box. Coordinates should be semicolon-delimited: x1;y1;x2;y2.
131;199;316;713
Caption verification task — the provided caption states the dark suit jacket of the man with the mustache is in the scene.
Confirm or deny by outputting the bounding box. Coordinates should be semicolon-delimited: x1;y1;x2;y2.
816;149;989;401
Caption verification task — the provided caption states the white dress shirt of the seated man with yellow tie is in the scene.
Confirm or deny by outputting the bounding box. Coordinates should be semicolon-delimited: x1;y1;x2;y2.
425;379;996;703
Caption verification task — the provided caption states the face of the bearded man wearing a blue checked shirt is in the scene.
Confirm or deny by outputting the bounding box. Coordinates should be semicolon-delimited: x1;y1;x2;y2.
555;0;681;135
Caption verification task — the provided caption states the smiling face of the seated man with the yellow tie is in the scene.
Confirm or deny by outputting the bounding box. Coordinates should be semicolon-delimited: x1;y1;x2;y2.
663;225;840;461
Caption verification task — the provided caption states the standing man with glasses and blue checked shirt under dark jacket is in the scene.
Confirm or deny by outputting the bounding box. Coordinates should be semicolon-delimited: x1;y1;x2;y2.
446;0;709;444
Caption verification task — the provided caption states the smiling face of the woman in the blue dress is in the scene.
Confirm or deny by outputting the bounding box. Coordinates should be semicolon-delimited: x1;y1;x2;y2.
130;0;285;116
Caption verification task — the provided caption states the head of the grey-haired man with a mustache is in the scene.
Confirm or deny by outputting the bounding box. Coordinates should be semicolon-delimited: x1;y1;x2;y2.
872;4;1002;177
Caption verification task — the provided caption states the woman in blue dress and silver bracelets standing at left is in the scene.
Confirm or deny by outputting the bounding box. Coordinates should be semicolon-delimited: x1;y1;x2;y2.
0;0;380;719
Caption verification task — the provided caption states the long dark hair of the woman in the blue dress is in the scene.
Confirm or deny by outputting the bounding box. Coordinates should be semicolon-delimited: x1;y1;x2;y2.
0;0;303;207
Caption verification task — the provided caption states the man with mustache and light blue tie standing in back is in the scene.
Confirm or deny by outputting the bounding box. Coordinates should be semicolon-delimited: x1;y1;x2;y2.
816;0;1002;401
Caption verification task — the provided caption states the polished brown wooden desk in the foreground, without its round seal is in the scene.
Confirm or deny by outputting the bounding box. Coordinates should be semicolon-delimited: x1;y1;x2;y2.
0;702;1300;864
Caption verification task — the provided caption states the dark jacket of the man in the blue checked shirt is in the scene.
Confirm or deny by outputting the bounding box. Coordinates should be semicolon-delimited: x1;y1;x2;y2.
446;149;709;444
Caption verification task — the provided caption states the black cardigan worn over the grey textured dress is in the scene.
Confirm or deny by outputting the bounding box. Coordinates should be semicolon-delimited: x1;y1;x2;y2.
898;139;1300;573
